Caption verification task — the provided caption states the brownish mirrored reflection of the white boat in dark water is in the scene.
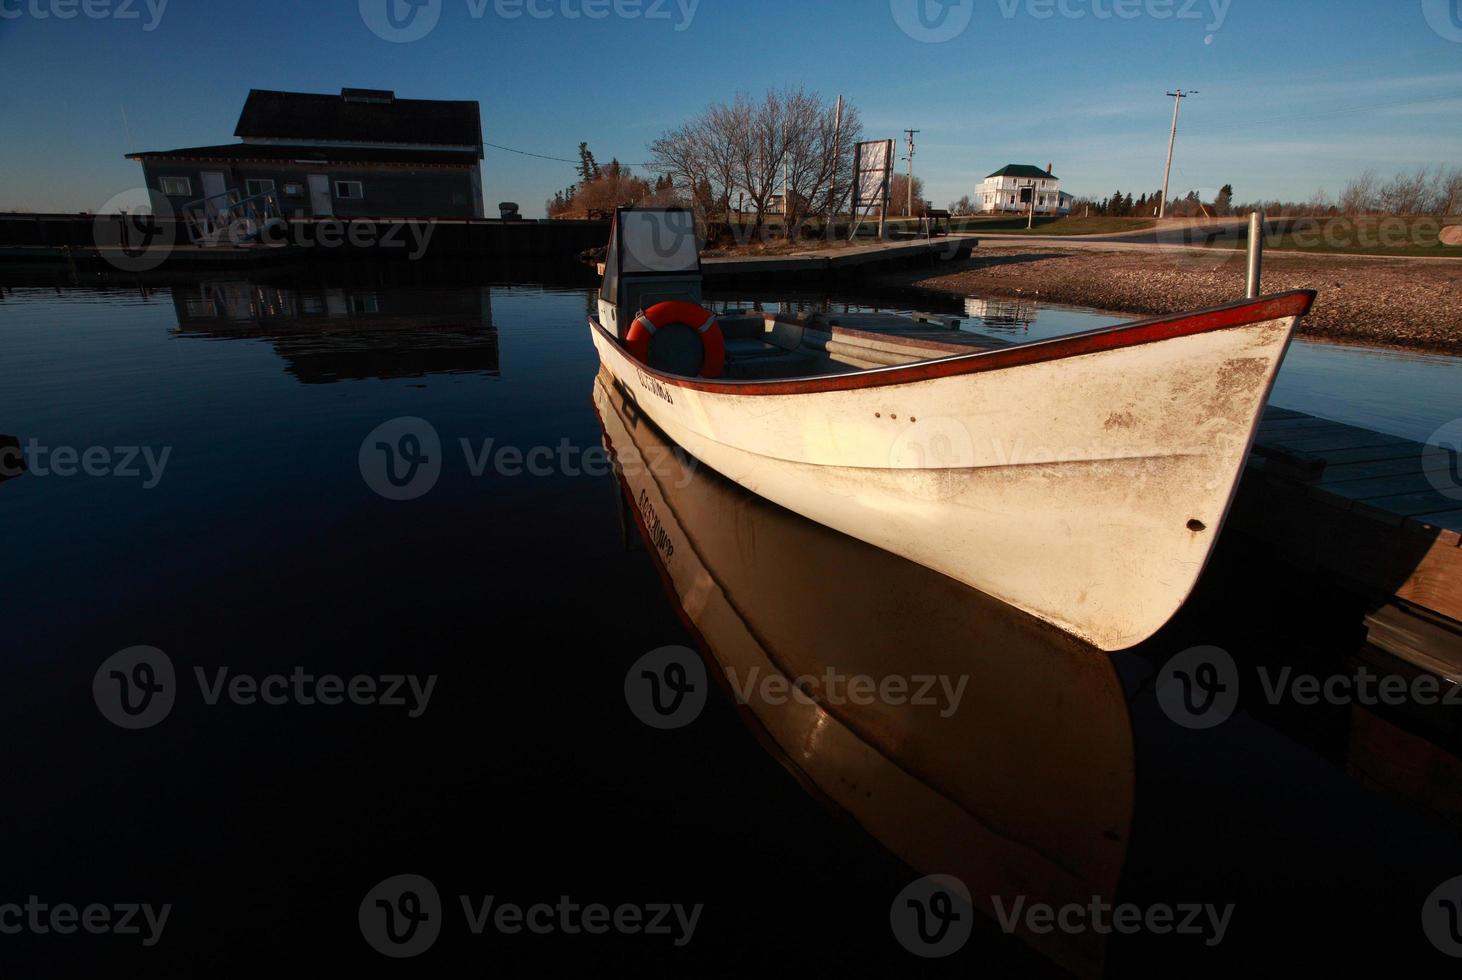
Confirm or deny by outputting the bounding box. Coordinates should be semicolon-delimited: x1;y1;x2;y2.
594;370;1133;976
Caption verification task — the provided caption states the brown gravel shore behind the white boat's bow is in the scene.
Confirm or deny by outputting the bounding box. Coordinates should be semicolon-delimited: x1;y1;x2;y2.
887;243;1462;354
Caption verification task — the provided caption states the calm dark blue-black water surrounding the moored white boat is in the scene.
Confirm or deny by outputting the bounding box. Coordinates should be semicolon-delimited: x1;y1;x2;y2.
0;270;1462;976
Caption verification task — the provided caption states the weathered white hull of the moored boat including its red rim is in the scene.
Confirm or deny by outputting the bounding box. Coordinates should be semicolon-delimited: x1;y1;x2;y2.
591;294;1310;651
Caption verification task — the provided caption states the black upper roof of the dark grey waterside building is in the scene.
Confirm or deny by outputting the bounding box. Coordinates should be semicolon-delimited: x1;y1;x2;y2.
234;89;482;158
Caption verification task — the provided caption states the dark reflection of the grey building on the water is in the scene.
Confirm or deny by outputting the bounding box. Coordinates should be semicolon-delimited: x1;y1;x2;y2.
173;279;499;383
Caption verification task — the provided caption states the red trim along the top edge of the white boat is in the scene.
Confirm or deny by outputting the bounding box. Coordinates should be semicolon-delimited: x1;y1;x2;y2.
589;290;1316;395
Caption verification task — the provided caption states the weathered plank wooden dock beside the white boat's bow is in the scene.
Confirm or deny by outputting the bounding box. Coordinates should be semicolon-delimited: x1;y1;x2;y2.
1230;407;1462;628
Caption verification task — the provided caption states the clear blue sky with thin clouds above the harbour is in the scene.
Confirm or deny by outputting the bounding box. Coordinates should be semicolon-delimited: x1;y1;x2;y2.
0;0;1462;215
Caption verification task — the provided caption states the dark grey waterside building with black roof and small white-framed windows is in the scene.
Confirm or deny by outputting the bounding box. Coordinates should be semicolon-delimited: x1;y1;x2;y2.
127;88;482;218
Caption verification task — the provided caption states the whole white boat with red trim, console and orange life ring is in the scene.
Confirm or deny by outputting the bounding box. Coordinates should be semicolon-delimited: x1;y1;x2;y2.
589;209;1314;651
